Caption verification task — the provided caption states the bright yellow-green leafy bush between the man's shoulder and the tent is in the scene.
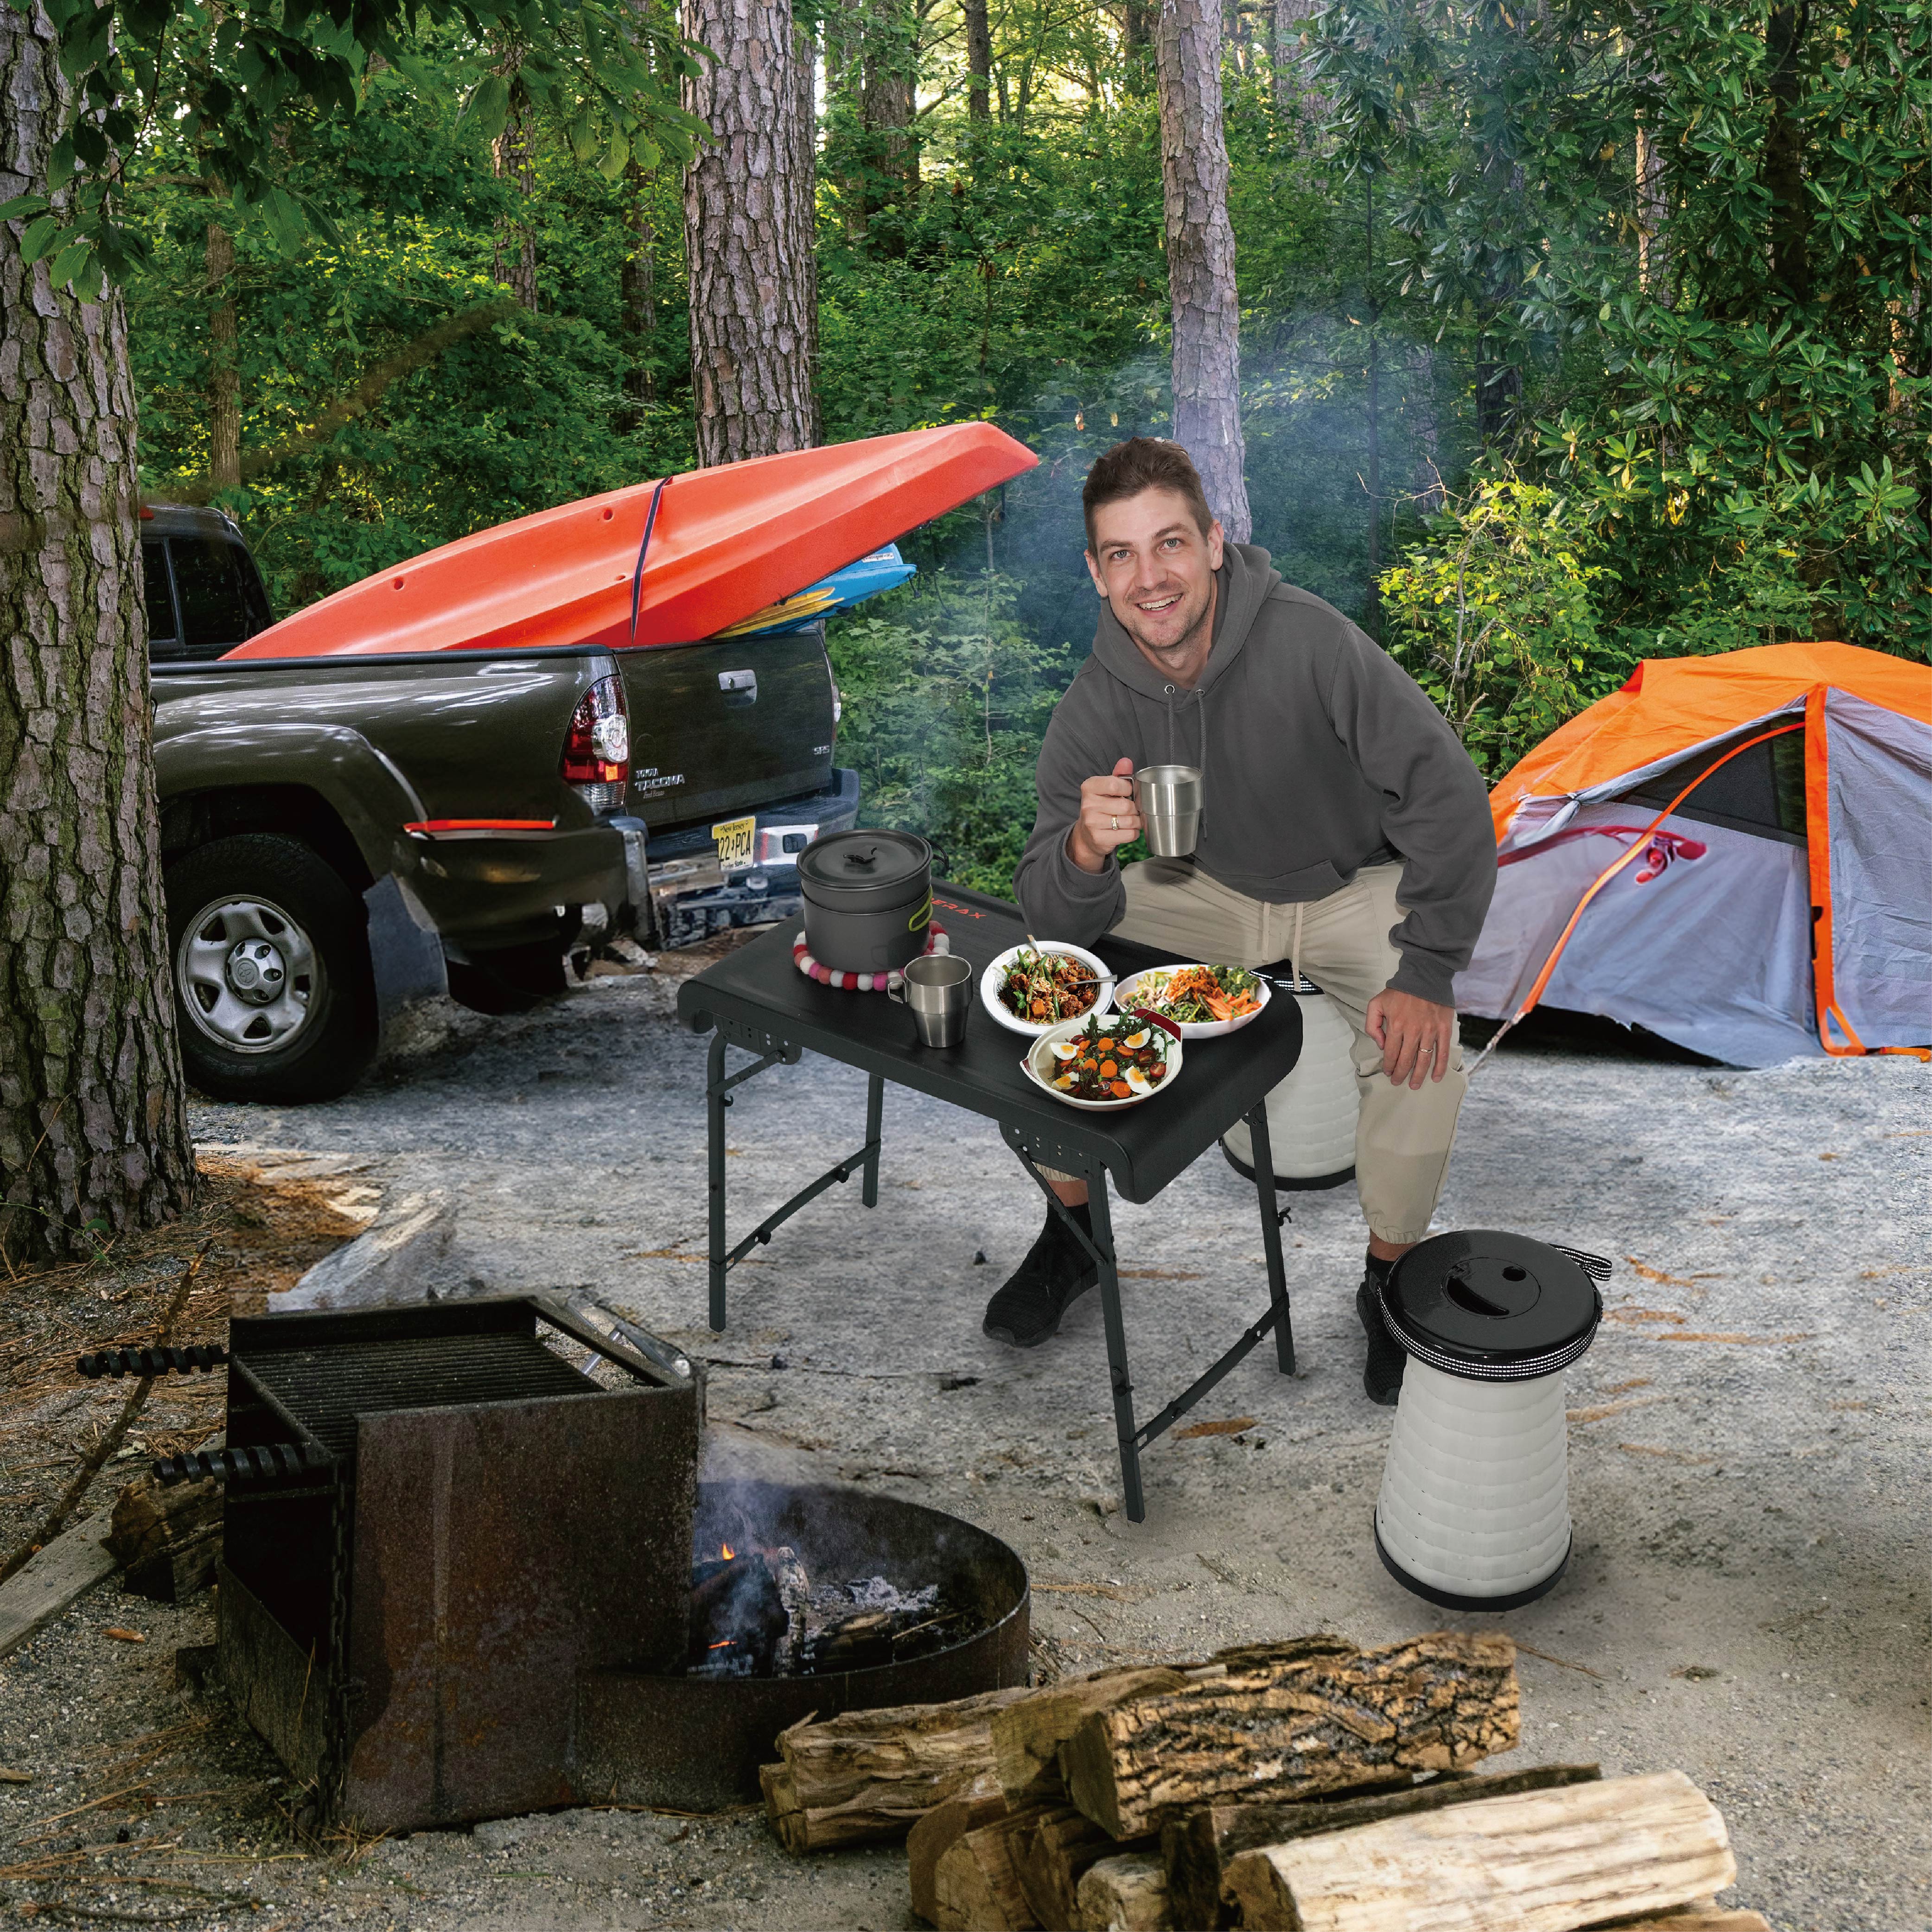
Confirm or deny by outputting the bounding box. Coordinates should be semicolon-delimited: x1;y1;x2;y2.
1381;477;1631;784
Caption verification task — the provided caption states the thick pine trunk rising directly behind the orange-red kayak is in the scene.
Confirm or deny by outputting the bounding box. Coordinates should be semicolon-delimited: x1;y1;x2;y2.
684;0;817;464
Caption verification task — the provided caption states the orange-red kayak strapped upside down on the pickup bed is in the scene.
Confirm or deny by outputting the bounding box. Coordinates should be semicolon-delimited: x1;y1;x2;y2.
228;423;1039;657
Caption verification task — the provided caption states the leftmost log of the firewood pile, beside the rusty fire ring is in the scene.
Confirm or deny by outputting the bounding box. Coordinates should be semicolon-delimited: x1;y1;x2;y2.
757;1690;1028;1853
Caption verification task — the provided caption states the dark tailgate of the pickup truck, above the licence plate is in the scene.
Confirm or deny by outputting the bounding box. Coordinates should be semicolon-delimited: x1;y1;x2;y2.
616;626;833;835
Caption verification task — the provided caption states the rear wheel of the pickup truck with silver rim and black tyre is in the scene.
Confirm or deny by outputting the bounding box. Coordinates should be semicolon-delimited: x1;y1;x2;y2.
166;833;377;1101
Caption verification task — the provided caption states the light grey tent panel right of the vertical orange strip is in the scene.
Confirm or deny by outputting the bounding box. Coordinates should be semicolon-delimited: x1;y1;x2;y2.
1824;690;1932;1047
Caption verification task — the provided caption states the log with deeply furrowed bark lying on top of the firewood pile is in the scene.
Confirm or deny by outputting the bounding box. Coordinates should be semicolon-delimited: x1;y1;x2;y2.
1061;1631;1517;1837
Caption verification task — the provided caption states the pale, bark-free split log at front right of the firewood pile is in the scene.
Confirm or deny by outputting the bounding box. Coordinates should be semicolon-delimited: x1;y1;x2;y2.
1227;1772;1737;1932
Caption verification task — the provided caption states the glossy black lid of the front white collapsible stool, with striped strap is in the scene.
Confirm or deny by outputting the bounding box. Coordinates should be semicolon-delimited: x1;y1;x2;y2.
1381;1227;1609;1381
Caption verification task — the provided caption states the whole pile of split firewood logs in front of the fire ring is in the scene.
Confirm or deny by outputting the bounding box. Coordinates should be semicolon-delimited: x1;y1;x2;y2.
763;1631;1768;1932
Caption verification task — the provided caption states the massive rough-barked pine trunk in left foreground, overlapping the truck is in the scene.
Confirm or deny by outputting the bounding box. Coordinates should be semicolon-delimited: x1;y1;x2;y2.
0;6;193;1268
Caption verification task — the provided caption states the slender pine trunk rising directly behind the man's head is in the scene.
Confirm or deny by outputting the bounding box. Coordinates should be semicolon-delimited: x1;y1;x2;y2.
1155;0;1254;543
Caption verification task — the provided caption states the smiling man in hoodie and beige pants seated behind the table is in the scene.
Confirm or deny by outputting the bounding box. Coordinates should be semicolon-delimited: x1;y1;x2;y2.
985;437;1495;1404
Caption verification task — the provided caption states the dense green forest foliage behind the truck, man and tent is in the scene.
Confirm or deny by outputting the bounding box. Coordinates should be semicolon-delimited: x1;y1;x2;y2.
128;0;1932;891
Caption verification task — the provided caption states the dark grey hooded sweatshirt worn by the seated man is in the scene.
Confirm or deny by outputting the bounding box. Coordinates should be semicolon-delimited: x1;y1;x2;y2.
1013;543;1495;1007
